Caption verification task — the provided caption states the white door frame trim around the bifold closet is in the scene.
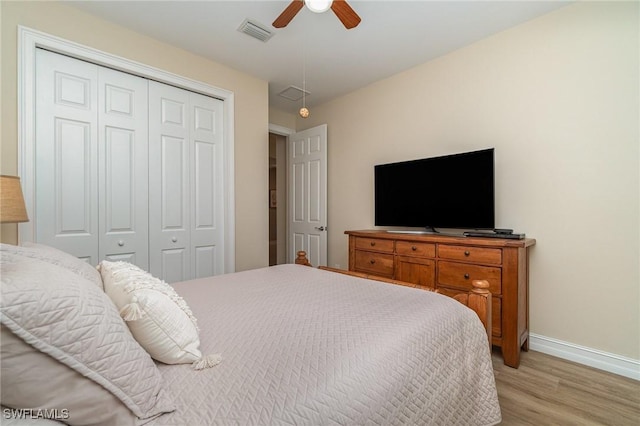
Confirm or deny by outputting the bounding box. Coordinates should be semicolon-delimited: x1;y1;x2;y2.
17;26;236;272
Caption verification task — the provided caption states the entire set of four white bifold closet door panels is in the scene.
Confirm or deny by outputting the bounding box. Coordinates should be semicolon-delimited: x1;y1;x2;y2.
33;50;225;282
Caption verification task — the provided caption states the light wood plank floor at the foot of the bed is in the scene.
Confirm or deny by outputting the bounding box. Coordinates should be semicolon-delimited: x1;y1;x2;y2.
493;348;640;426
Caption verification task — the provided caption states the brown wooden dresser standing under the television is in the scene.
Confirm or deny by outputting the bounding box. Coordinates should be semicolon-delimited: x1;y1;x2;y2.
345;230;536;368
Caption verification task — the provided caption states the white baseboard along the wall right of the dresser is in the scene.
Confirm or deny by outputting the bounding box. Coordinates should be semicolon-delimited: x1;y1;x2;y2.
529;334;640;380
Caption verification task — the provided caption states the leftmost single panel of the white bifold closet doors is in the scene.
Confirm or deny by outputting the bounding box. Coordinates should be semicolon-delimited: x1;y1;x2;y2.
35;49;99;265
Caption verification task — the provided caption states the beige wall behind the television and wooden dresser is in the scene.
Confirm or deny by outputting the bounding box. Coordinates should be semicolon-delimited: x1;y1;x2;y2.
297;2;640;360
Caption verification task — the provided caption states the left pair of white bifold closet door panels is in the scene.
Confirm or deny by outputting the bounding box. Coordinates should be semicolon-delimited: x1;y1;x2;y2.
32;49;148;269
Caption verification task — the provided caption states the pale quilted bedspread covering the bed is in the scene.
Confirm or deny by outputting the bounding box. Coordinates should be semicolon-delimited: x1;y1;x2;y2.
149;265;501;425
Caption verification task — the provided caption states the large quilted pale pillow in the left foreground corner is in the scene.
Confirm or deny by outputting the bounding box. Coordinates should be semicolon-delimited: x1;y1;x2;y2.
0;251;175;423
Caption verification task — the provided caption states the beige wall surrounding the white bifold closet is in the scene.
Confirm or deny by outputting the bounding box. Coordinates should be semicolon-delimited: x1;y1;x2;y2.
0;0;269;270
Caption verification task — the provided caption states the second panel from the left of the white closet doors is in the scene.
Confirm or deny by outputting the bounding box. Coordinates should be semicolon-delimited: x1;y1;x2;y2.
98;67;149;270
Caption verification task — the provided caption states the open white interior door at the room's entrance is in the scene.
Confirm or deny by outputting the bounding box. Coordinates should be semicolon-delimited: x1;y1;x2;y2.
287;124;327;266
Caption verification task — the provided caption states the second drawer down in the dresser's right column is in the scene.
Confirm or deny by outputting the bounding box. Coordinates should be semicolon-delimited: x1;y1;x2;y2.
438;261;502;294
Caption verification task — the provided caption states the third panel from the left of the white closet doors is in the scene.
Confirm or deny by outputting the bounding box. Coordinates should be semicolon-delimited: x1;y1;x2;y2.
149;81;192;282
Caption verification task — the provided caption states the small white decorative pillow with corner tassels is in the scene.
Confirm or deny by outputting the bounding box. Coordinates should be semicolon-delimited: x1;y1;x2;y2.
98;260;222;370
